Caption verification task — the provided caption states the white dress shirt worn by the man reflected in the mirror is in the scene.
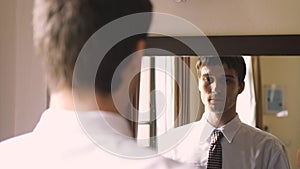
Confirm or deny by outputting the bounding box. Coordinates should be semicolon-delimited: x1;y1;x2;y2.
164;114;290;169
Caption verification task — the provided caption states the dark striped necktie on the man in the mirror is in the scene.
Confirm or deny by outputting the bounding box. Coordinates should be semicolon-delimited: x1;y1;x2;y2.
207;130;223;169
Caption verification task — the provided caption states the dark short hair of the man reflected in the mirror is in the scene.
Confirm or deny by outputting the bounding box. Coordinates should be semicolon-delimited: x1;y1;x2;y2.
196;55;246;85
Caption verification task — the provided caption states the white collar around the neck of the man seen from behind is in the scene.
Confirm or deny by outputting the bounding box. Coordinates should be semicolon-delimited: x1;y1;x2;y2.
34;108;132;137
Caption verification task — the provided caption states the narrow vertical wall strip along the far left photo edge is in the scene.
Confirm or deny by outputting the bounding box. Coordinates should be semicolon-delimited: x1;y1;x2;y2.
0;0;16;140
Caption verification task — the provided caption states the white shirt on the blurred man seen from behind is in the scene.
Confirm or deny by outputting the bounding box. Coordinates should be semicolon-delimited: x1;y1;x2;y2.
0;109;195;169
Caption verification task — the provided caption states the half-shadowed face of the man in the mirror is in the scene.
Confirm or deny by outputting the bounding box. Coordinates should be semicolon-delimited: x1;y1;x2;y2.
199;64;244;113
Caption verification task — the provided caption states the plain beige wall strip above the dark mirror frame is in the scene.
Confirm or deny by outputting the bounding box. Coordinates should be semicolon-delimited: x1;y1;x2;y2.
150;0;300;35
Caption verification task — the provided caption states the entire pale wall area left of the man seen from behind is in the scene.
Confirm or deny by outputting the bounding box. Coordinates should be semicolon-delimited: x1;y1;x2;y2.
0;0;46;140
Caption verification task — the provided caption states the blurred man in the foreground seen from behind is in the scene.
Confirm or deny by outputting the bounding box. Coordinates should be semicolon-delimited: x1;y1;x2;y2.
0;0;192;169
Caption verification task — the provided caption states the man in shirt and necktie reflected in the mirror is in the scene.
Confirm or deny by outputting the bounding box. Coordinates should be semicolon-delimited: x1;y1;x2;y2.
166;56;290;169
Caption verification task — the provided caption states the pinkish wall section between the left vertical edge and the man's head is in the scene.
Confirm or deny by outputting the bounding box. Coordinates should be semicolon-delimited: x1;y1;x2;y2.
15;0;47;135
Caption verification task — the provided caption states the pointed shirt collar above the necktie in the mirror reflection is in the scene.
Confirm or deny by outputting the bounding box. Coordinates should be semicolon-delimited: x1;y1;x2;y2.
199;113;241;143
